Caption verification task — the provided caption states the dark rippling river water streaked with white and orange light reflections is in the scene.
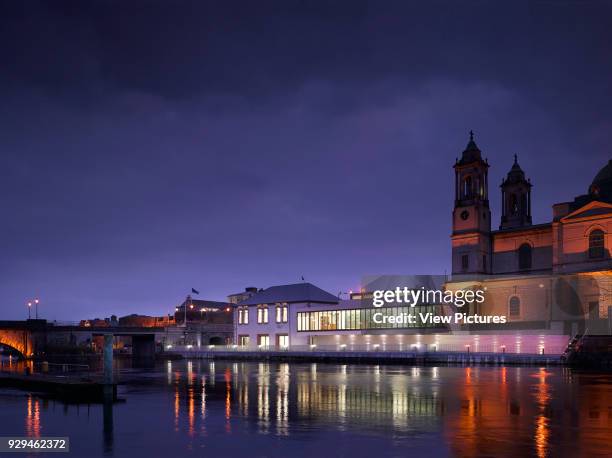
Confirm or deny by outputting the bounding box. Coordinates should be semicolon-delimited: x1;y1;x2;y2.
0;361;612;458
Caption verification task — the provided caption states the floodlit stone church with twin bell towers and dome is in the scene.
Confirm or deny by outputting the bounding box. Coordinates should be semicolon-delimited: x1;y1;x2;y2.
446;134;612;335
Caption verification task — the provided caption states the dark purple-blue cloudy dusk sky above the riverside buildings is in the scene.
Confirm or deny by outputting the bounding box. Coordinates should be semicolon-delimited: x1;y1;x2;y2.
0;0;612;320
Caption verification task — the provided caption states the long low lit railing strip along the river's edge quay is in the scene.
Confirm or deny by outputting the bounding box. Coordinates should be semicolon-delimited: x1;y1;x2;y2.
165;344;566;355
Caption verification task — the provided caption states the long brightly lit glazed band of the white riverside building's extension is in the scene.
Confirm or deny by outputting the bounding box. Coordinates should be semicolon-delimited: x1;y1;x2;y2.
297;305;443;332
